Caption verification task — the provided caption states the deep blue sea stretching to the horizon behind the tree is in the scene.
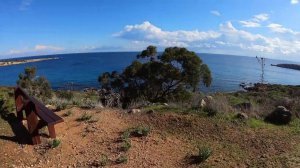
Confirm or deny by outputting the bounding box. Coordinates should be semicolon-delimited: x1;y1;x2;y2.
0;52;300;92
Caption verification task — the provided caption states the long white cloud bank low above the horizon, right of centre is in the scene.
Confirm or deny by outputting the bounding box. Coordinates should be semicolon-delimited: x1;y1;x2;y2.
114;19;300;56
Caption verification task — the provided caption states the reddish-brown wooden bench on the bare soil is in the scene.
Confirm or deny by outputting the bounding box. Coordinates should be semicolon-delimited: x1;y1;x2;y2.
15;87;64;145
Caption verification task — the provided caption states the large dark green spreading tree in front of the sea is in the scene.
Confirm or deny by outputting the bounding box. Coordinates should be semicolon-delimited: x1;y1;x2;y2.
98;46;212;106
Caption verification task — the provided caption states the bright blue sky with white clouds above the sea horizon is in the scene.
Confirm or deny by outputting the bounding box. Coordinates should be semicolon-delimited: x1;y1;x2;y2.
0;0;300;62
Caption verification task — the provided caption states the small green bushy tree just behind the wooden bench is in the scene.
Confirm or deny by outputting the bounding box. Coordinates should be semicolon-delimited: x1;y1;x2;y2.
17;67;52;102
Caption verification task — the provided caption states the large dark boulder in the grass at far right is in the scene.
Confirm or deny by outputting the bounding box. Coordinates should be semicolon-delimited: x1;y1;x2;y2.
265;106;292;124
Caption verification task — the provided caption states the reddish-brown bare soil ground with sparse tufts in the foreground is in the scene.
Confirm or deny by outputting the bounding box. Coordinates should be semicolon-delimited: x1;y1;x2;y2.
0;108;300;168
